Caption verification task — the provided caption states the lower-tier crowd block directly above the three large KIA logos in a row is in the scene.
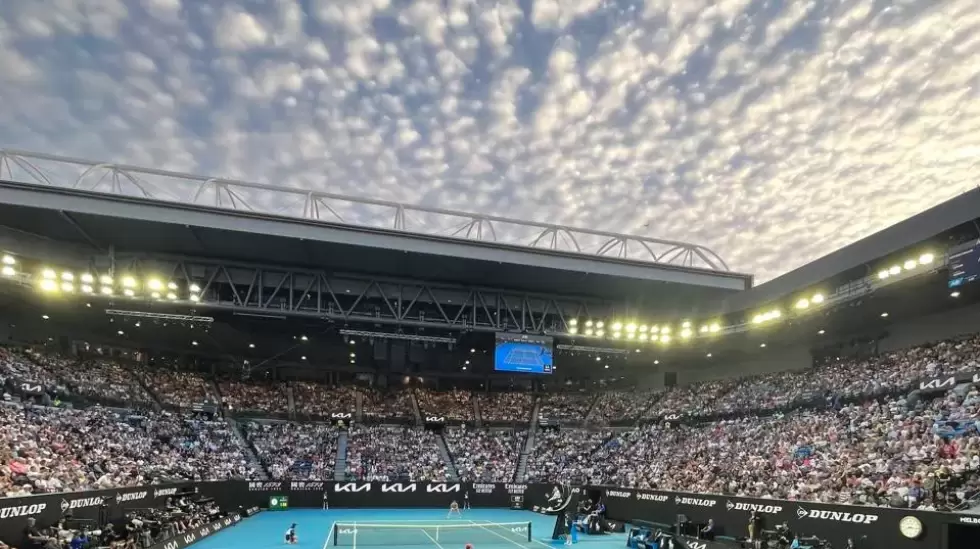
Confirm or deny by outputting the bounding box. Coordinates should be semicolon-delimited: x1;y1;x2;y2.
346;425;450;481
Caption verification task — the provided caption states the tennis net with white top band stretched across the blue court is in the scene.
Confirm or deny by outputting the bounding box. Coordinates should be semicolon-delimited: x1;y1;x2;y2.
333;522;531;547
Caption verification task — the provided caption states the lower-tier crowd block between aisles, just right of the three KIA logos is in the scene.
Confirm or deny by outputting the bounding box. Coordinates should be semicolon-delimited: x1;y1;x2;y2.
443;427;527;482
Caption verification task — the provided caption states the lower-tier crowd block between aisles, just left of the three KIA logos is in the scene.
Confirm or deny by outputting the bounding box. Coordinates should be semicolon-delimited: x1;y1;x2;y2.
244;422;339;480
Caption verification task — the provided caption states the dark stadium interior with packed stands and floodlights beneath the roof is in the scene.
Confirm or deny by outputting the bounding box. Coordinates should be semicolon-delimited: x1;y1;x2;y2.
0;182;980;549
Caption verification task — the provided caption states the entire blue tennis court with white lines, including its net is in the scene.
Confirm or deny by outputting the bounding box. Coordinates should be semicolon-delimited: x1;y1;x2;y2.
191;509;626;549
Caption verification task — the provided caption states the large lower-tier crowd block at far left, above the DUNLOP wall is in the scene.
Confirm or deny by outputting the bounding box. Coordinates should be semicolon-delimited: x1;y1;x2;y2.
0;403;256;496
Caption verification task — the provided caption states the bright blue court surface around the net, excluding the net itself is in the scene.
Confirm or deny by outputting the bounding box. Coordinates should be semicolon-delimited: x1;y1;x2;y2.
191;509;626;549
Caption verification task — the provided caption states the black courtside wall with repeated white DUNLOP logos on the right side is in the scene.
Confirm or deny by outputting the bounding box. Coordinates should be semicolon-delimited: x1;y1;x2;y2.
586;487;961;549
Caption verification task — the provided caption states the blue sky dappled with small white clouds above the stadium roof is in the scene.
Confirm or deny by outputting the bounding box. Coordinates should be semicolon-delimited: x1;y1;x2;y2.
0;0;980;280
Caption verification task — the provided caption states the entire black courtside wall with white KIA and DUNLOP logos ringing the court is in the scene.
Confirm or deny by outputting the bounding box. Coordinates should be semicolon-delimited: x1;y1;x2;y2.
0;481;980;549
